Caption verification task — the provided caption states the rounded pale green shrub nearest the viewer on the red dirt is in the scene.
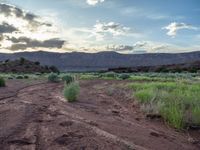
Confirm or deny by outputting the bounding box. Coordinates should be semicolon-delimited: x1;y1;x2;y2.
63;82;80;102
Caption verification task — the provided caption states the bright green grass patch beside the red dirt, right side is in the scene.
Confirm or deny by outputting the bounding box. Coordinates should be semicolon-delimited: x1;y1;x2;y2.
129;81;200;129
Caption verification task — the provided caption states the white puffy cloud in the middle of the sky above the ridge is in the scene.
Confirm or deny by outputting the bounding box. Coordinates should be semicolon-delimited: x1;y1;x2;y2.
92;21;130;40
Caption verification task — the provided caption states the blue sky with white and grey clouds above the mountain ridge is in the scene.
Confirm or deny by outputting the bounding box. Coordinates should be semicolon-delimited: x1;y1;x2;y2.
0;0;200;53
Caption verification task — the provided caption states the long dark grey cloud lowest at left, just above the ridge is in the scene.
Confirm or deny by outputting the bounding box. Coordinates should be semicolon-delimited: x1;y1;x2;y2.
9;37;65;51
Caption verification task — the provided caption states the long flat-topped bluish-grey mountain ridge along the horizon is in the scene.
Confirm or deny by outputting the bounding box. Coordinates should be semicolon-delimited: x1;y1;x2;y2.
0;51;200;71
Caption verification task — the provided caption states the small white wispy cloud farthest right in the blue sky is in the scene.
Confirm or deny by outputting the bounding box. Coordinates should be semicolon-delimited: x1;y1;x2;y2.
162;22;197;37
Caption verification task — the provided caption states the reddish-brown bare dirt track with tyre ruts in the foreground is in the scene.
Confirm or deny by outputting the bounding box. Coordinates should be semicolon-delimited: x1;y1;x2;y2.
0;80;200;150
